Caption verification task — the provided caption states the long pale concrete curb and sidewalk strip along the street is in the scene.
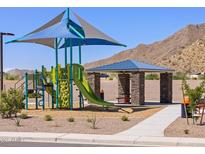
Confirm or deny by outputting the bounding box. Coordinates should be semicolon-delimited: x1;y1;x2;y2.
0;132;205;147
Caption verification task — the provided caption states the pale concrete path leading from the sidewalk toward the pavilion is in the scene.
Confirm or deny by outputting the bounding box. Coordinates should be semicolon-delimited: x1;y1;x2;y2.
116;104;180;137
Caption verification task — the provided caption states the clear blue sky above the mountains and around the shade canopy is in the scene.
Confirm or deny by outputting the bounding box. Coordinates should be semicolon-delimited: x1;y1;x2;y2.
0;8;205;70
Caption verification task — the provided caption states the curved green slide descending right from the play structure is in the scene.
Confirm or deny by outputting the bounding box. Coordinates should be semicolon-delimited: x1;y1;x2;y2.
73;64;113;106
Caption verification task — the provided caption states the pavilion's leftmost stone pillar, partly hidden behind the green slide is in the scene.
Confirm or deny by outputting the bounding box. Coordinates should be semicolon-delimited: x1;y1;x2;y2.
88;73;100;97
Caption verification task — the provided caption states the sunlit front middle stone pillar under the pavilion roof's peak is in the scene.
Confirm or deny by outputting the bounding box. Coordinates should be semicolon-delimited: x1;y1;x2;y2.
131;72;145;106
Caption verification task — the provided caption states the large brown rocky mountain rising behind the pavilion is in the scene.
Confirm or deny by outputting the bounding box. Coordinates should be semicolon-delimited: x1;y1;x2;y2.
85;24;205;73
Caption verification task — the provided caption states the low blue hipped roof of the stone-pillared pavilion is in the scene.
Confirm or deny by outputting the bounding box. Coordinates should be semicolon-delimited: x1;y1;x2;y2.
87;60;174;72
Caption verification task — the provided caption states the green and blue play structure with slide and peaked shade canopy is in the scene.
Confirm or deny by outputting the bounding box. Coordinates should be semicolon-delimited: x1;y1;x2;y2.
7;9;125;110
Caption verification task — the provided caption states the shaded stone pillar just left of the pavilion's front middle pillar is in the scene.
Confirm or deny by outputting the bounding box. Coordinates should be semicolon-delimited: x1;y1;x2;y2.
118;74;130;103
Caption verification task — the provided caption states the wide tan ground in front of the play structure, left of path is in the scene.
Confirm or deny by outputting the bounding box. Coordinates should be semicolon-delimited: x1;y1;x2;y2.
0;107;162;134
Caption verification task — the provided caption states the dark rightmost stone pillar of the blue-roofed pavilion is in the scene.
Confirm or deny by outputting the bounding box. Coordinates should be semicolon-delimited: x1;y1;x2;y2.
160;73;172;103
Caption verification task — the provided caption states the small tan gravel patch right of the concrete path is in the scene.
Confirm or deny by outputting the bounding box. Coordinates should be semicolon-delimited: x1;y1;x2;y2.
165;118;205;138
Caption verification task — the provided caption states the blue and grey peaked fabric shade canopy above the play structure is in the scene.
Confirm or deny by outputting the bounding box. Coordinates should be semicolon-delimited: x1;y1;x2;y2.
7;11;125;48
